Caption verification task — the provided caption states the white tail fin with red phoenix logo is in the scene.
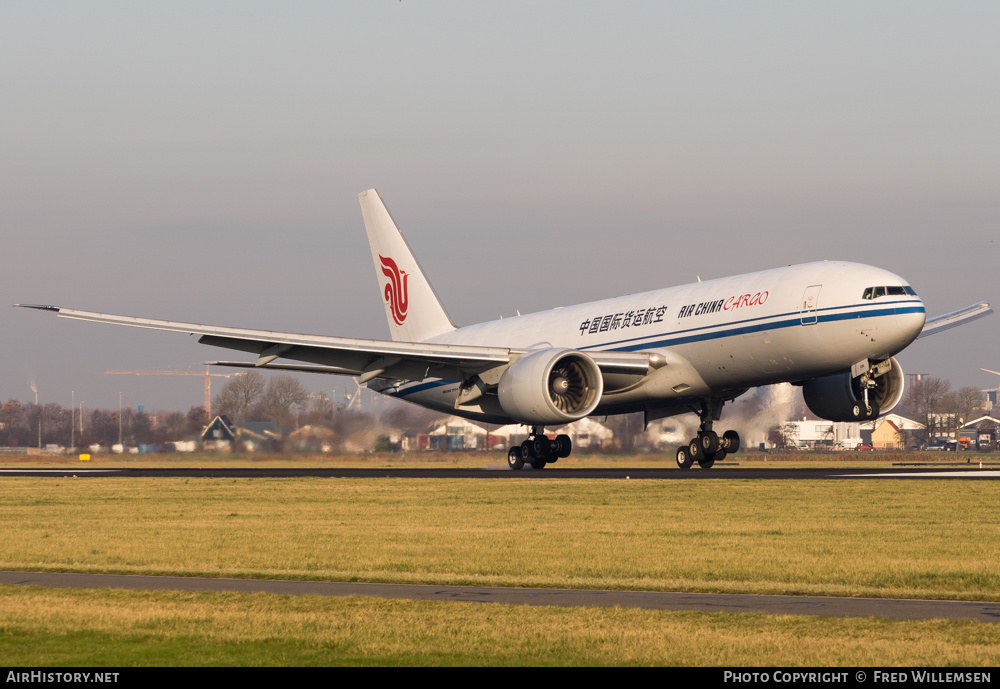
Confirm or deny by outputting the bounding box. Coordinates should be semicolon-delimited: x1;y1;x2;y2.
358;189;455;342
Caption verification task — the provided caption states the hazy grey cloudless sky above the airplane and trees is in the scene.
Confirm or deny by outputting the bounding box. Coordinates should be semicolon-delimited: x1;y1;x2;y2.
0;0;1000;409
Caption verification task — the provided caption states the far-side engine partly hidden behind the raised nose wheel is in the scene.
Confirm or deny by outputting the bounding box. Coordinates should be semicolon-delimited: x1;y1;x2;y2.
802;357;904;421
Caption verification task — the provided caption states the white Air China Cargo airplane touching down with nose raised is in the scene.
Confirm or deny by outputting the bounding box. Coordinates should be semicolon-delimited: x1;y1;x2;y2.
15;189;993;470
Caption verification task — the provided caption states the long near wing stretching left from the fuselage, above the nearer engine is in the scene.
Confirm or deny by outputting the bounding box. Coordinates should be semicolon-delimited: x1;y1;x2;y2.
14;304;649;383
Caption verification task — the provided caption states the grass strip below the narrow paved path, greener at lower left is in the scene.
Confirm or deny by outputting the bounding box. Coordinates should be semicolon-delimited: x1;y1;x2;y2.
0;587;1000;667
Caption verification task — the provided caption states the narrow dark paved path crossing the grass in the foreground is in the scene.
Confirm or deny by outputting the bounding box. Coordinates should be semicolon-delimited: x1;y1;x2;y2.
0;572;1000;624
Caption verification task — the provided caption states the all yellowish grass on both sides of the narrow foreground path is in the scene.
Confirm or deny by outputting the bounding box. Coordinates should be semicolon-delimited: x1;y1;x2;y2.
0;456;1000;665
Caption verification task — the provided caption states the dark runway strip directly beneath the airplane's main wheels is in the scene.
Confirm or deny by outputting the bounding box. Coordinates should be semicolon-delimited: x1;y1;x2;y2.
0;464;1000;481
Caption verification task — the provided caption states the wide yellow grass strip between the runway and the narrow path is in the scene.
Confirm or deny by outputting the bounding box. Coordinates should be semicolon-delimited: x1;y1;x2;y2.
0;478;1000;600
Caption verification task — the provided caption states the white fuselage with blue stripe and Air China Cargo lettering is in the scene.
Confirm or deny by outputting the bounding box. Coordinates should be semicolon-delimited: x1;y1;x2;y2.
373;261;925;423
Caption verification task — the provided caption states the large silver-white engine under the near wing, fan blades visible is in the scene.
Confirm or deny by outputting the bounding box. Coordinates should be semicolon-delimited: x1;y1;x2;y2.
497;348;604;426
